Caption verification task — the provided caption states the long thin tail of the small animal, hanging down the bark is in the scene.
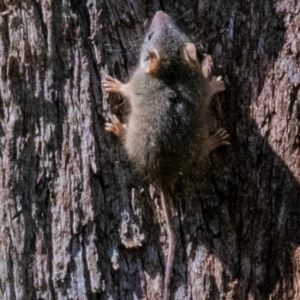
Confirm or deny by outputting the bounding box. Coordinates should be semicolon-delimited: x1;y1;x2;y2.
161;189;177;300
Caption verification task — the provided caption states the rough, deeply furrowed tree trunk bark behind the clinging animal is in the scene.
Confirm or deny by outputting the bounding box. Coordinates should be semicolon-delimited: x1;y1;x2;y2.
0;0;300;300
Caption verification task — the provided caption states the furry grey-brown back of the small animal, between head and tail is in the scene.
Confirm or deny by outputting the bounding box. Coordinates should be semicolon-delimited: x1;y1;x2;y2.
125;72;203;180
